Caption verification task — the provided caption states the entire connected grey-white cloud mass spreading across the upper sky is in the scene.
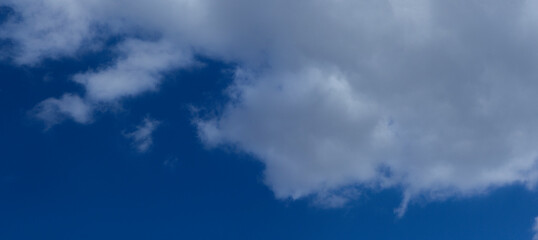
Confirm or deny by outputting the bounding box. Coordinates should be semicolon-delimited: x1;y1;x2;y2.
5;0;538;212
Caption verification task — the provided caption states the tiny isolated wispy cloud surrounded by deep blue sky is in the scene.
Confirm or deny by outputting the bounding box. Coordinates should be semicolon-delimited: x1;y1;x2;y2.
125;118;161;152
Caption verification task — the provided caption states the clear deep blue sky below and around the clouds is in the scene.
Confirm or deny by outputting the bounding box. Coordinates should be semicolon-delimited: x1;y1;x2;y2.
0;49;538;240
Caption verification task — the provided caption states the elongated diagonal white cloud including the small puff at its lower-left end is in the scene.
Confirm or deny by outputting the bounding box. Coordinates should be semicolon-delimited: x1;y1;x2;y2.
33;39;191;127
